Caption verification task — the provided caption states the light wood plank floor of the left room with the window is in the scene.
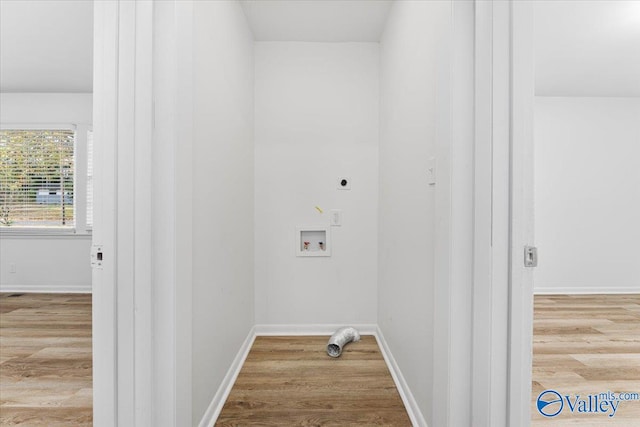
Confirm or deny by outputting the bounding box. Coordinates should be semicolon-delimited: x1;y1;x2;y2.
0;293;92;427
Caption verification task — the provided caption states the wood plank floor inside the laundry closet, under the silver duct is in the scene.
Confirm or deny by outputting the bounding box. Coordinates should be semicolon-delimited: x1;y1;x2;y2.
216;336;411;427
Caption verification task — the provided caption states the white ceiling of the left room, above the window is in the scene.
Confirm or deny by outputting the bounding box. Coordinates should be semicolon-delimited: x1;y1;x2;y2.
0;0;93;92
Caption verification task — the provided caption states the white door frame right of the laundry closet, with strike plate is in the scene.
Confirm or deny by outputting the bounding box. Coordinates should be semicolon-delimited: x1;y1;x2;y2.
471;0;534;427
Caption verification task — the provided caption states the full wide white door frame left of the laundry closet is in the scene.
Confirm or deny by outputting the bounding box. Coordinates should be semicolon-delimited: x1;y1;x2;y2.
92;0;193;427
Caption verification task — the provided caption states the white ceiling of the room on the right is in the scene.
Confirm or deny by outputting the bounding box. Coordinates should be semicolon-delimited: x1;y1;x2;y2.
534;0;640;96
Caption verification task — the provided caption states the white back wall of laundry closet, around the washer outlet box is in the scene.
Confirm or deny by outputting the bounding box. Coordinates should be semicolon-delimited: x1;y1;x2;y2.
254;42;379;324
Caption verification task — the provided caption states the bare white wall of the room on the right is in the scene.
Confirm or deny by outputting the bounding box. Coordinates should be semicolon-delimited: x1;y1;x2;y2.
534;97;640;293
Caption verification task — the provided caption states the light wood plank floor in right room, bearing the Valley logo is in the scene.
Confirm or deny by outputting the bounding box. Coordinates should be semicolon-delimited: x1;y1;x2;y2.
531;294;640;427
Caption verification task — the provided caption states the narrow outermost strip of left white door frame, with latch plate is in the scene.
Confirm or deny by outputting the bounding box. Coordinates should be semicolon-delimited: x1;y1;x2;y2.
91;1;119;427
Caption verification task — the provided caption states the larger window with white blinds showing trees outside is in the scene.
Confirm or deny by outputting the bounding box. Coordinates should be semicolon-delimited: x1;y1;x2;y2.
0;129;75;229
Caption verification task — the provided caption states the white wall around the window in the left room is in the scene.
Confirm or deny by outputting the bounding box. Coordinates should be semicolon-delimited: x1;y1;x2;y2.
0;93;92;292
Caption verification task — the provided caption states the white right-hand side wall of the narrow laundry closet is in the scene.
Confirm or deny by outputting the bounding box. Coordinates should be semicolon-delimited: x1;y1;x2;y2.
378;2;450;422
